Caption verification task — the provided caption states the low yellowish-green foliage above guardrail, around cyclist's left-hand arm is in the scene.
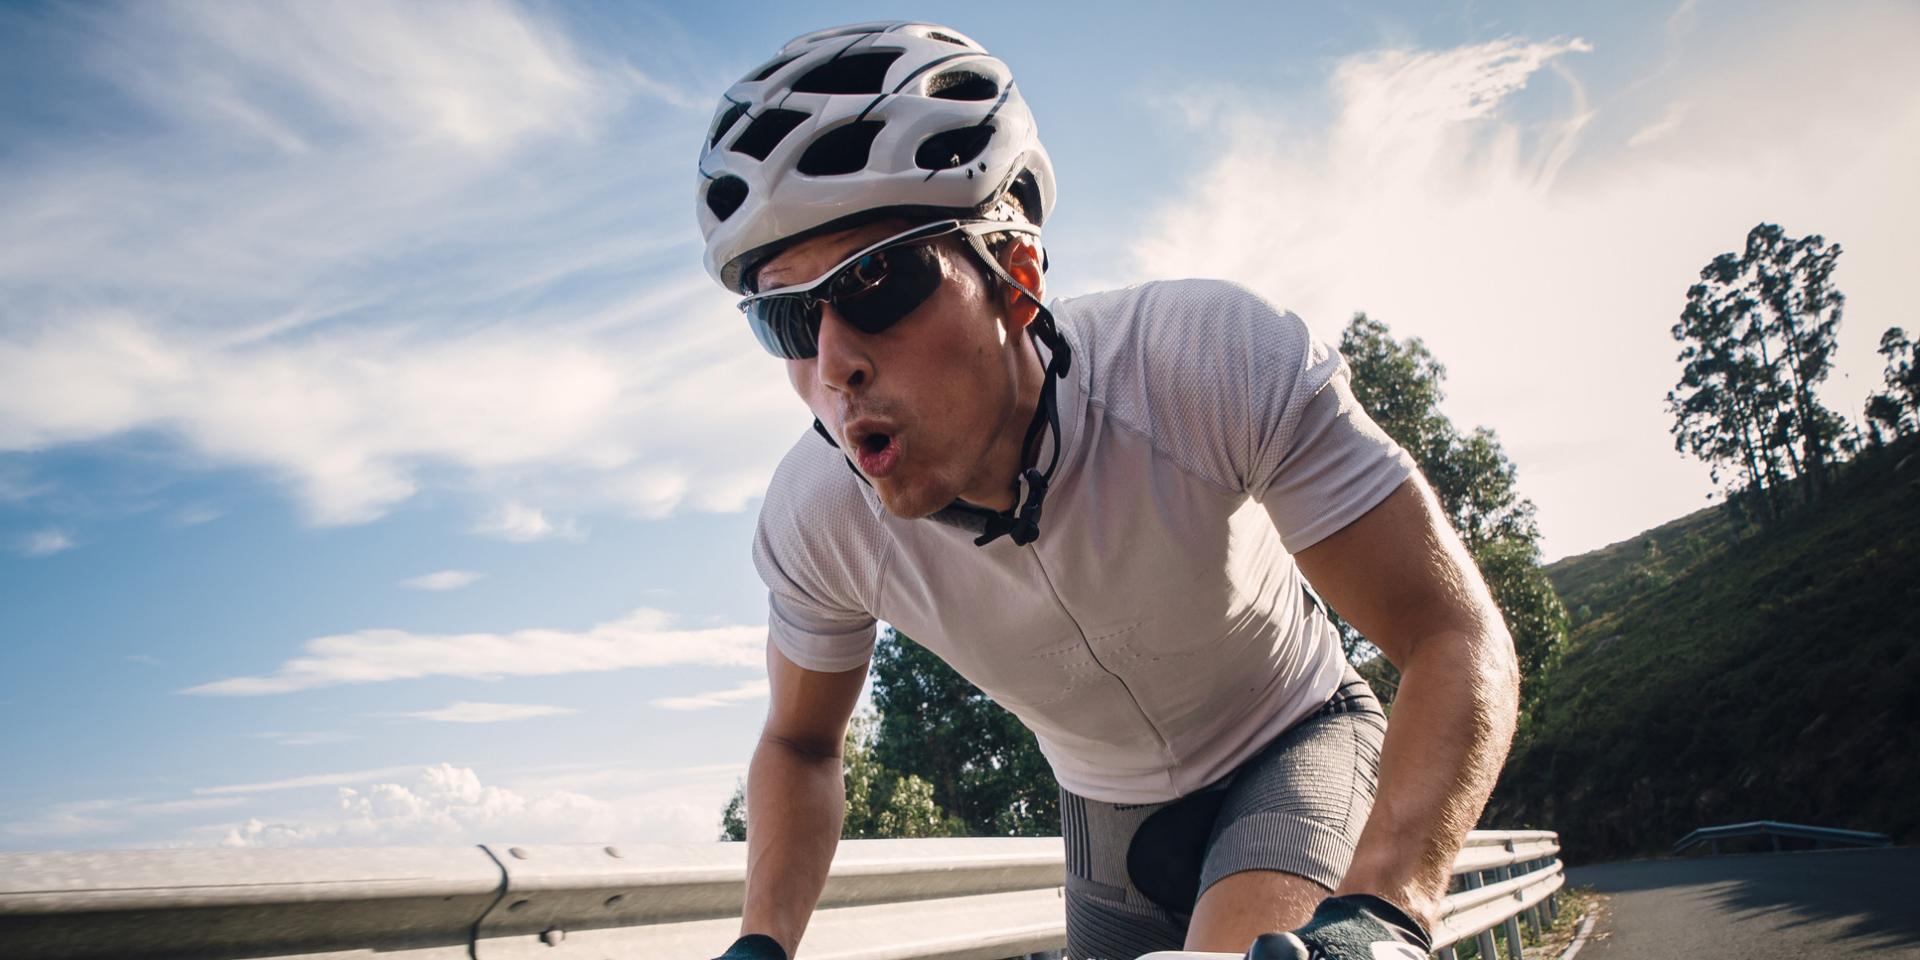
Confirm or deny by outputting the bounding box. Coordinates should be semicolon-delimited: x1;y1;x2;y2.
720;714;966;841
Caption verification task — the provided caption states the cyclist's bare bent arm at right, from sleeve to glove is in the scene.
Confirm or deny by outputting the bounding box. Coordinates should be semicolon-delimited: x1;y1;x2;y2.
1296;476;1519;929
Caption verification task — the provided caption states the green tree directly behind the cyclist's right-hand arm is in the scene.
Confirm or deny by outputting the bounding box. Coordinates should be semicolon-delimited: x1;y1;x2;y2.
1334;313;1567;703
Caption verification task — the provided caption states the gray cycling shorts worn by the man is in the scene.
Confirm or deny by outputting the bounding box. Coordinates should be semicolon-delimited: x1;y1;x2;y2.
1060;668;1386;960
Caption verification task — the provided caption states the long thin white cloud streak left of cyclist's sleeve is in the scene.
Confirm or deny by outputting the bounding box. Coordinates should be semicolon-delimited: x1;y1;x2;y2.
180;607;766;697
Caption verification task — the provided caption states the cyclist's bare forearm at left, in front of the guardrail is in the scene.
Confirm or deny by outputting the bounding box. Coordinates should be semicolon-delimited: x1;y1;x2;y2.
741;737;847;956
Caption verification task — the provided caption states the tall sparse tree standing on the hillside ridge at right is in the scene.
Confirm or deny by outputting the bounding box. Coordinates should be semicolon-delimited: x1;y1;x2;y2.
1667;223;1847;520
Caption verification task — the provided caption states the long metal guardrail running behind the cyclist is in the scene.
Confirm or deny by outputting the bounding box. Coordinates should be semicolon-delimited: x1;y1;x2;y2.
0;831;1563;960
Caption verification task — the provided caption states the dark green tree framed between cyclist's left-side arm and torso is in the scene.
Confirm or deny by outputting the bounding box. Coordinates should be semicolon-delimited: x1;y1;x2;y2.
874;630;1060;837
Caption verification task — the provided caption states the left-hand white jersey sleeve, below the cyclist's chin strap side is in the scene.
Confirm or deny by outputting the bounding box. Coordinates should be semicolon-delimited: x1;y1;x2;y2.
753;438;877;672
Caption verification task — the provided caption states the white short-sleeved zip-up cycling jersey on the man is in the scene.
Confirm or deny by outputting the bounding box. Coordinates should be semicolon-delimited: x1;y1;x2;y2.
753;280;1415;803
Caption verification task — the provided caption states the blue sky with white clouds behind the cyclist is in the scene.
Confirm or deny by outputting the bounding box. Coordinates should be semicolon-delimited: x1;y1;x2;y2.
0;0;1920;851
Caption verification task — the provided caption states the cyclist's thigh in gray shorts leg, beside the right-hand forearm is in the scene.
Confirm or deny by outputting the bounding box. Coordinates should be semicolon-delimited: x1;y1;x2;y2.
1200;668;1386;902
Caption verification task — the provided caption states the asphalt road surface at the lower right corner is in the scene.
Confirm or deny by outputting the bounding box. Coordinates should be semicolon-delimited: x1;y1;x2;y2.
1567;847;1920;960
